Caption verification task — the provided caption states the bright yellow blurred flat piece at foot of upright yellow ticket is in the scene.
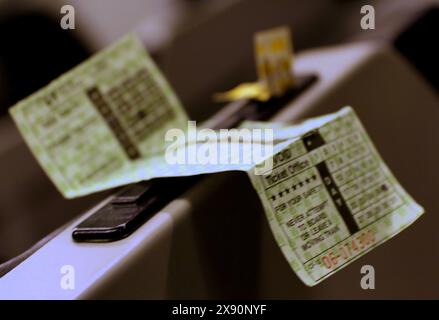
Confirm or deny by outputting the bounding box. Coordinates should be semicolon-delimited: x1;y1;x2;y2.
213;82;271;102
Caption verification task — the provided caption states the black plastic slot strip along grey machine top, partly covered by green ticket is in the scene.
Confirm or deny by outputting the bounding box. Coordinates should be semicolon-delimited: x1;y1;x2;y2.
72;75;317;242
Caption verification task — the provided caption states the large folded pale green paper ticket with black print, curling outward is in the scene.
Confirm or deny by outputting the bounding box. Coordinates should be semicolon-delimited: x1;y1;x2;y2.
10;35;423;285
